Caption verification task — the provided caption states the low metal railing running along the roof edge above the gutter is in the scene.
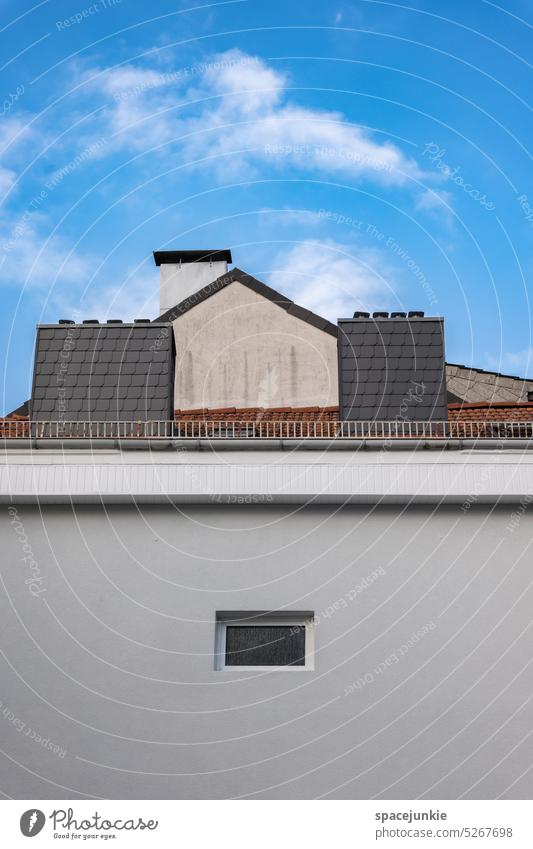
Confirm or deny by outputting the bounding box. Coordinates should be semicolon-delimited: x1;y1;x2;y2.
0;419;533;441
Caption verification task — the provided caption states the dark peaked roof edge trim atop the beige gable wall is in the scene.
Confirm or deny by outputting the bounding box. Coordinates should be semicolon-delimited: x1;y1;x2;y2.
156;268;337;337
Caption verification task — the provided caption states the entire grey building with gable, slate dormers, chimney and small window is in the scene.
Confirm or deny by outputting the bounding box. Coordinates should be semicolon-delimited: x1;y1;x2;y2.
0;251;533;799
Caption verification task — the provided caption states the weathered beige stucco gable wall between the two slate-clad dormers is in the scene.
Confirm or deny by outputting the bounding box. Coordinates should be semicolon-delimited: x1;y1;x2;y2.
174;282;338;410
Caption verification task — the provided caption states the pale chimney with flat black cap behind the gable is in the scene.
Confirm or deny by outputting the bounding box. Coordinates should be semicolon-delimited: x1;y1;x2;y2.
154;250;231;315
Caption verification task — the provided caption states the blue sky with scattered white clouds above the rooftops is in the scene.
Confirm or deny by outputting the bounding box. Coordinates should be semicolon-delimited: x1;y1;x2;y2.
0;0;533;411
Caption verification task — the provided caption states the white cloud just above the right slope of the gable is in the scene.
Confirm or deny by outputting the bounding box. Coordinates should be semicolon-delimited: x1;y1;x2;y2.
270;240;396;322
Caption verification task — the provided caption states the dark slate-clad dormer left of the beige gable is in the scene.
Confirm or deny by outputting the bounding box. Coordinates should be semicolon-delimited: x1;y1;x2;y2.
31;322;174;422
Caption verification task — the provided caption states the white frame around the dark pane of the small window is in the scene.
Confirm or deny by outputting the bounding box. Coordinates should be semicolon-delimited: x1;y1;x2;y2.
215;610;315;673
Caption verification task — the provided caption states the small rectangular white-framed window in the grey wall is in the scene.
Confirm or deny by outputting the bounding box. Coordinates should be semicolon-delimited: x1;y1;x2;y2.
216;611;314;670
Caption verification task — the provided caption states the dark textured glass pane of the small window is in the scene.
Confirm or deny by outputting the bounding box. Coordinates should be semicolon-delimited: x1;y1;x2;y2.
226;625;305;666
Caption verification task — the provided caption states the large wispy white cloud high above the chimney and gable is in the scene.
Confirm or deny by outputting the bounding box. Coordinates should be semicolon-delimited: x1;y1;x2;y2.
85;50;421;185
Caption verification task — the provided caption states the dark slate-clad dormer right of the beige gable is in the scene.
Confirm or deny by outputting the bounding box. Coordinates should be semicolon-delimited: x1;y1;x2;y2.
338;318;447;422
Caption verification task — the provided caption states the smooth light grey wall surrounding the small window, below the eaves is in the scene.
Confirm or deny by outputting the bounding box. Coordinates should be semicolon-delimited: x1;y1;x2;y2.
0;500;533;799
